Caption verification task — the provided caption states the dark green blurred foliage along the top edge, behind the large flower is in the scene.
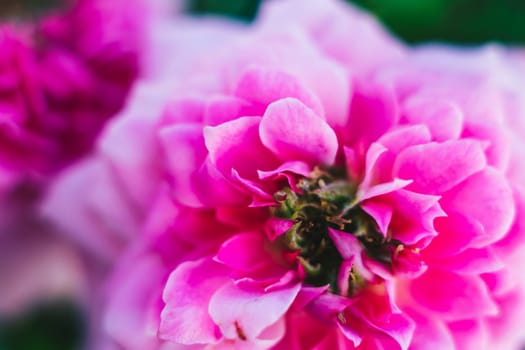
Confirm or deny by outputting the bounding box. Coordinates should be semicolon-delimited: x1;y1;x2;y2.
190;0;525;44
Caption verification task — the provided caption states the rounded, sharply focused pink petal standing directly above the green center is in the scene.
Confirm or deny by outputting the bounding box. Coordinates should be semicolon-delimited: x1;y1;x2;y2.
260;98;338;165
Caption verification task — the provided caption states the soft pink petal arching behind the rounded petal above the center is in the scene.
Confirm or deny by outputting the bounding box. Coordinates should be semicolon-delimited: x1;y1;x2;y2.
235;67;324;117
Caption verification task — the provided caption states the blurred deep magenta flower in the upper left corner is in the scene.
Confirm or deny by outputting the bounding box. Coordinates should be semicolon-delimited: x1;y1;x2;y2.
0;0;149;181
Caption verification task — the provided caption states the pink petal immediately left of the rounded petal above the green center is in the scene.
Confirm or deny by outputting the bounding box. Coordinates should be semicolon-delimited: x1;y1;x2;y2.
204;117;277;180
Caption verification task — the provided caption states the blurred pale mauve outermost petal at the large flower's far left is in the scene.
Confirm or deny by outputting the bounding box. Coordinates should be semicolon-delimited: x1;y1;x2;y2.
41;158;130;261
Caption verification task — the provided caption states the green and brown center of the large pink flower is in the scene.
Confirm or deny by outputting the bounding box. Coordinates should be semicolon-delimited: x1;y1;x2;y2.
273;168;401;296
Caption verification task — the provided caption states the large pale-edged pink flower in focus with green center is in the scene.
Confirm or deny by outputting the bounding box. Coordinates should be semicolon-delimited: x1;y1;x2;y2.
34;0;525;350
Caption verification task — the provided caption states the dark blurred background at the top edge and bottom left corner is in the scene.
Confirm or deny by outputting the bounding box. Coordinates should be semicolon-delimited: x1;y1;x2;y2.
0;0;525;350
